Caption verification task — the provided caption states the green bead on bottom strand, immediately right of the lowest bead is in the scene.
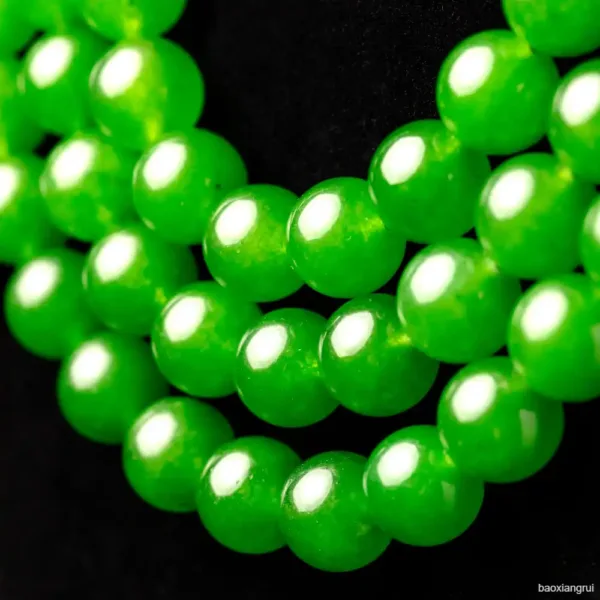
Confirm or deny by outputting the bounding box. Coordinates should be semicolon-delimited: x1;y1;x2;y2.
364;425;483;546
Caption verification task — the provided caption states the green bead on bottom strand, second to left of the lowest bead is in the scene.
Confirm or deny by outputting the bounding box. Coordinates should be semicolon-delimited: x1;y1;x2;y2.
123;397;233;512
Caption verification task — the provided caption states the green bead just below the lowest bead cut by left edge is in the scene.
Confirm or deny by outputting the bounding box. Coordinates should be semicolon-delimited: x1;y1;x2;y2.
4;249;100;359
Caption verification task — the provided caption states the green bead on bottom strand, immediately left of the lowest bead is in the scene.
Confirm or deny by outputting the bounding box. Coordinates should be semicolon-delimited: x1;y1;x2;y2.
197;437;300;554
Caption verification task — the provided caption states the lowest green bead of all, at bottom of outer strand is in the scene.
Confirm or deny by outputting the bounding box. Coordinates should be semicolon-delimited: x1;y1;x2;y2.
281;452;390;572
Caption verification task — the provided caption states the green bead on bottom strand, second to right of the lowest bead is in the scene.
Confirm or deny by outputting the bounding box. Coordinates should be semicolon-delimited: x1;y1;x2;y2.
438;356;564;483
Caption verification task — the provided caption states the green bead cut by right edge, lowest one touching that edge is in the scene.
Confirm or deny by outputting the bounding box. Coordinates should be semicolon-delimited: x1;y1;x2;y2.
508;273;600;402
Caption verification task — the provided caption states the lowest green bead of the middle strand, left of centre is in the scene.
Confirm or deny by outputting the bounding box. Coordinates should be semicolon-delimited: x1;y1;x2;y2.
235;308;338;427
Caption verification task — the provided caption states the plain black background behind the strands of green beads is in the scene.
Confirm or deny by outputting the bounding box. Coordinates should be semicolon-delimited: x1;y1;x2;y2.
0;0;600;600
